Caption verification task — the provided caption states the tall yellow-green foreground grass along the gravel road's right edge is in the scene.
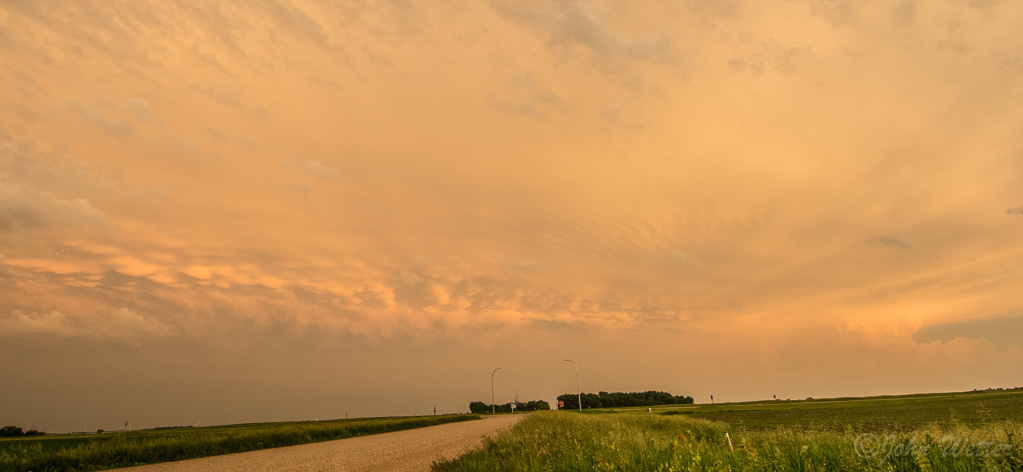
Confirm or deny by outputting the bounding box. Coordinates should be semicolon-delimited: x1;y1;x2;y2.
435;412;1023;472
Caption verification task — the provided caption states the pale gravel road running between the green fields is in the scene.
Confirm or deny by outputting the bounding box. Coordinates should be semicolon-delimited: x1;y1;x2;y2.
116;415;525;472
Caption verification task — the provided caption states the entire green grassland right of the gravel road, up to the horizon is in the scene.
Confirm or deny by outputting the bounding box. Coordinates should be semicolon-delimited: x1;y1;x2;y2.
435;390;1023;472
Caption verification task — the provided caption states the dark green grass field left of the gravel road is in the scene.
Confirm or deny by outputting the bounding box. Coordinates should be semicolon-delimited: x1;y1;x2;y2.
0;415;479;472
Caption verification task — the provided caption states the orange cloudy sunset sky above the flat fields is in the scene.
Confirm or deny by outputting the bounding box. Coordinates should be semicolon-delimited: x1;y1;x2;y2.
0;0;1023;431
